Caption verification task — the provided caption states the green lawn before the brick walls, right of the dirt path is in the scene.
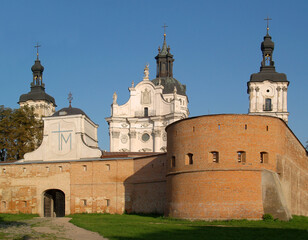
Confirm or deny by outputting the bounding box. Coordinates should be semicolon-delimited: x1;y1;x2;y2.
69;214;308;240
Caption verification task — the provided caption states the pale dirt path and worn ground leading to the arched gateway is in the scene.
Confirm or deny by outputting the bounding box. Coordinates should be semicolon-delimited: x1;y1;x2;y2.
0;218;107;240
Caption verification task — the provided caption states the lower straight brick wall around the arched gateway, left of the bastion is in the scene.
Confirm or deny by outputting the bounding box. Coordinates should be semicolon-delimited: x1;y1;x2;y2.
0;154;166;216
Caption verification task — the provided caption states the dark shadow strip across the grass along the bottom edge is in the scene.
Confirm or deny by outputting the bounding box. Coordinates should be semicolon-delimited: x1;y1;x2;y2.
110;226;308;240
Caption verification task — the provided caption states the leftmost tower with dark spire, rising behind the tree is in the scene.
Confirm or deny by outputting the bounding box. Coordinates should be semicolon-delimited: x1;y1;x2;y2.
18;45;57;118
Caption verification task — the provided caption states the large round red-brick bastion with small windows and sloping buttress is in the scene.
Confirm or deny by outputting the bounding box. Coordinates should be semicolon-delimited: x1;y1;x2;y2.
165;114;308;219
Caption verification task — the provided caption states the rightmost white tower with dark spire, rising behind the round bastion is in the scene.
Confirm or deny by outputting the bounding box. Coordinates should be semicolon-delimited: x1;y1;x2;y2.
247;21;289;123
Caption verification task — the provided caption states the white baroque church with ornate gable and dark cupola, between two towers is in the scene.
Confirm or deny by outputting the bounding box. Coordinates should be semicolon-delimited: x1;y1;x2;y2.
106;34;189;152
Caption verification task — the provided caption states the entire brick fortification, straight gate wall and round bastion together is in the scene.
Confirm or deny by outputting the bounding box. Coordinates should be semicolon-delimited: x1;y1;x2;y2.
0;115;308;219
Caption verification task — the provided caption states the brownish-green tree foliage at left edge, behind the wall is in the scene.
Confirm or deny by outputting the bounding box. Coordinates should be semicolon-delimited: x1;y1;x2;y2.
0;106;43;161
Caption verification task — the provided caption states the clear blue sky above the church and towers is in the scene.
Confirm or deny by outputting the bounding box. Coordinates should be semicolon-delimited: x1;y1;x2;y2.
0;0;308;150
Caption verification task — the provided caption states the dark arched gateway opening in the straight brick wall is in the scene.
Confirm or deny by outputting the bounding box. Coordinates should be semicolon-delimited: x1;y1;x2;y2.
43;189;65;217
